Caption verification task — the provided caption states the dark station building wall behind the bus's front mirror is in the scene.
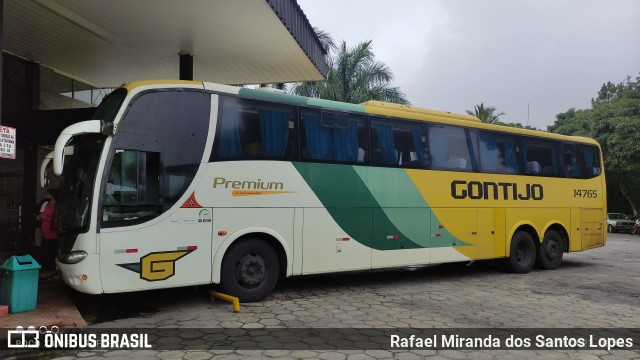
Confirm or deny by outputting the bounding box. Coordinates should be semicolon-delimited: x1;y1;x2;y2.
0;53;94;253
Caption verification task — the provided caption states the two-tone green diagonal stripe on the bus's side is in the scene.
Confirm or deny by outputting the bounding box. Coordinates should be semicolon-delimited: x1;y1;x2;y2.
293;163;468;250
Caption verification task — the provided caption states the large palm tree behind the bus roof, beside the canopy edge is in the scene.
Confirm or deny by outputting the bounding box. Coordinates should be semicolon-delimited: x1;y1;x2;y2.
292;39;409;105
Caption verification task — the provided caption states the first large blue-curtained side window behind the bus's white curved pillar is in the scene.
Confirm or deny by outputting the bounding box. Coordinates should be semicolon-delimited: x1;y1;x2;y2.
214;97;297;160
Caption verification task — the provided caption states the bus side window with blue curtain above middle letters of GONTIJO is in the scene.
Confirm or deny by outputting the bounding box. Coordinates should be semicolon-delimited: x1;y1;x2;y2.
480;132;520;174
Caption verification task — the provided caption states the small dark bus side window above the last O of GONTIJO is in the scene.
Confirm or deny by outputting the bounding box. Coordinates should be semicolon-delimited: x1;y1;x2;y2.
524;139;560;176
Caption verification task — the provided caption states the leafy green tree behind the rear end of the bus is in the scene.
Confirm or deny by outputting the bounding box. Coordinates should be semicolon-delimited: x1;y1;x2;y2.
548;73;640;215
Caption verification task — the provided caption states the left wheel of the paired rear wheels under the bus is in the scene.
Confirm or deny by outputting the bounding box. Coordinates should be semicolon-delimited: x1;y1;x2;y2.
506;225;540;274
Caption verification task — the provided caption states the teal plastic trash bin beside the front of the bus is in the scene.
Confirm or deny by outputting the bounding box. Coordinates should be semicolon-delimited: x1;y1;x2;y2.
0;255;40;314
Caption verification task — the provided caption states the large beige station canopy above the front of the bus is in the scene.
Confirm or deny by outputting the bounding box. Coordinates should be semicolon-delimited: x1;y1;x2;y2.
3;0;326;87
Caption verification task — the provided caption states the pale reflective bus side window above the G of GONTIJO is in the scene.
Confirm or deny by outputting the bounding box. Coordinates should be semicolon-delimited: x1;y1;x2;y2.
429;125;478;171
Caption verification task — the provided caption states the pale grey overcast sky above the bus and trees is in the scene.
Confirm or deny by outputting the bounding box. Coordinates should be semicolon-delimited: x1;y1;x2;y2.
298;0;640;130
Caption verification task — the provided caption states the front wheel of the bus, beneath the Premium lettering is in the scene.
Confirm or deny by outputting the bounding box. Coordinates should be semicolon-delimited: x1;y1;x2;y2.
220;239;279;302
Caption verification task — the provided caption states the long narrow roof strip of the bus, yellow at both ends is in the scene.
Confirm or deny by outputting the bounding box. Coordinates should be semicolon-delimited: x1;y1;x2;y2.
122;80;599;146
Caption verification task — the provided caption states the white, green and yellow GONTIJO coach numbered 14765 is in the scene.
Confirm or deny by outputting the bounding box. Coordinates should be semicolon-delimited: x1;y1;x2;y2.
53;81;606;301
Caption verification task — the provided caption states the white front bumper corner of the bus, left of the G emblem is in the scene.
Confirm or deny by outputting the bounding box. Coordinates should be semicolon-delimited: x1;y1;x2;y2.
56;254;102;294
